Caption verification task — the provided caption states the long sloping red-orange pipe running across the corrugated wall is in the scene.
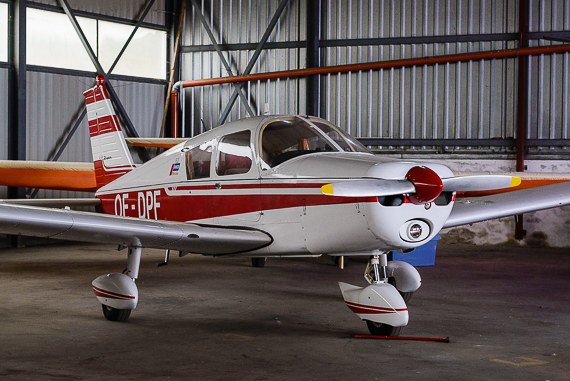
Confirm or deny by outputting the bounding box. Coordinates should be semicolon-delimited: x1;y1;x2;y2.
173;44;570;87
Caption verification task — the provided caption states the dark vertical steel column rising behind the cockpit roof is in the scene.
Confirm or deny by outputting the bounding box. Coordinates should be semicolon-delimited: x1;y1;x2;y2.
306;0;320;115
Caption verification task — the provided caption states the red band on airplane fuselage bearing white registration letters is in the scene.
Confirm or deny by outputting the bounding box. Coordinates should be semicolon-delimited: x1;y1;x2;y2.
99;183;376;221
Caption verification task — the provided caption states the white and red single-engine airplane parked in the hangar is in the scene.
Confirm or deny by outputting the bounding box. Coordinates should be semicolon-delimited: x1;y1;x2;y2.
0;78;570;335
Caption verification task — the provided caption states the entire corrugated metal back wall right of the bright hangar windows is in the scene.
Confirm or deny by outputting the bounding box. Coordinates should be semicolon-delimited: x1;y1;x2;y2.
182;0;570;154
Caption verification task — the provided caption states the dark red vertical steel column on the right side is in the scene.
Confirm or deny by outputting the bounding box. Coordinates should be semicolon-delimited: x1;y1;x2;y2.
515;0;530;240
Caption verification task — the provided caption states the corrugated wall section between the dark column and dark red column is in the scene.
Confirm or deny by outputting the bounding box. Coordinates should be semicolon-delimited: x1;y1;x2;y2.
321;0;517;139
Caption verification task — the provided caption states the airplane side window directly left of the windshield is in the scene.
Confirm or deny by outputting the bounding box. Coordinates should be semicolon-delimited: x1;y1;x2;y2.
216;130;252;176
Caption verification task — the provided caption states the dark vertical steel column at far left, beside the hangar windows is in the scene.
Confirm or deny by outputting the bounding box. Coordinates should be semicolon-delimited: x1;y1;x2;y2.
8;0;27;198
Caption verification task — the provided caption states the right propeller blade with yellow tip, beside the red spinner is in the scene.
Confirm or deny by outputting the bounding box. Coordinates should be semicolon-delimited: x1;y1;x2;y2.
442;175;521;192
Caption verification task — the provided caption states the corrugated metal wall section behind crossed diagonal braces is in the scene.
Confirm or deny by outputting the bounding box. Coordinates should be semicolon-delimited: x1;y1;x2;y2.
181;0;306;136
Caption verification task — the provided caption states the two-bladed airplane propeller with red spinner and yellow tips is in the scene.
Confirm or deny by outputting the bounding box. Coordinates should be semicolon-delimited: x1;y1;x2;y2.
321;166;521;204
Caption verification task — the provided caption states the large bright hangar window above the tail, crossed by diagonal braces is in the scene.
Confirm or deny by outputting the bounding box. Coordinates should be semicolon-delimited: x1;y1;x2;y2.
26;8;166;79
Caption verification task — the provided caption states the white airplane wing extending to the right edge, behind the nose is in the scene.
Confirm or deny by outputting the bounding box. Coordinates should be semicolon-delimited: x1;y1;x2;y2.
443;182;570;228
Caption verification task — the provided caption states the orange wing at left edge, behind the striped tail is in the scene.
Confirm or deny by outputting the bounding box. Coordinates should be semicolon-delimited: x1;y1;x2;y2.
0;160;97;192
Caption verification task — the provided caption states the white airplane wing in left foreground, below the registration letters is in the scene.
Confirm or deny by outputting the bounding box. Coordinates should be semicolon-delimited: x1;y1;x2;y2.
0;204;273;255
